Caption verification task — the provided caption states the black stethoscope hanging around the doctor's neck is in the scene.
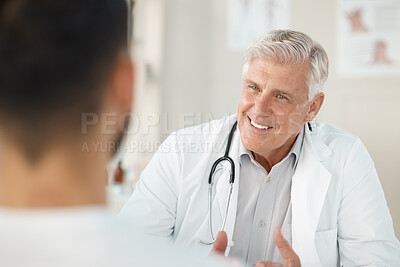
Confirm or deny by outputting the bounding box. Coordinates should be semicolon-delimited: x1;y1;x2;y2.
200;121;237;245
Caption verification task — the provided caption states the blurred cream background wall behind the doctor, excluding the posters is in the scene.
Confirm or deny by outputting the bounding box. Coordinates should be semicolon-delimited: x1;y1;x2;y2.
123;0;400;237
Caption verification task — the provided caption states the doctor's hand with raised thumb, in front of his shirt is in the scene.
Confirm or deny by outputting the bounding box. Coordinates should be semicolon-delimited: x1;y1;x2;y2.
256;227;301;267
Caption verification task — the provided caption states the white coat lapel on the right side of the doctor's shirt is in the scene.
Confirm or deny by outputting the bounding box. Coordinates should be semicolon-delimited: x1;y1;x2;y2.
291;128;331;266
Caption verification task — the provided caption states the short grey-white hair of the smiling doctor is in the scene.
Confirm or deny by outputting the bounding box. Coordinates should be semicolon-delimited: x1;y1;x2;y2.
243;30;329;101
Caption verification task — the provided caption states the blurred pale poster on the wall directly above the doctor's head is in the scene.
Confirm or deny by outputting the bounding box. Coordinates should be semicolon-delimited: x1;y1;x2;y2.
228;0;291;51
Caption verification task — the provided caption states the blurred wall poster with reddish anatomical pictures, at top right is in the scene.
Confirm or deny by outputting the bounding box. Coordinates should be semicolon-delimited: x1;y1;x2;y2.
338;0;400;76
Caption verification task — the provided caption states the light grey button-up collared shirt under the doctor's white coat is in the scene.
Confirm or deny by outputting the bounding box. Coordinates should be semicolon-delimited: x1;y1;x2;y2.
229;127;304;266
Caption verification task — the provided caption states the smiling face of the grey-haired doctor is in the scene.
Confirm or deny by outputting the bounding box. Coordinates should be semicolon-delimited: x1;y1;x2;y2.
238;58;323;158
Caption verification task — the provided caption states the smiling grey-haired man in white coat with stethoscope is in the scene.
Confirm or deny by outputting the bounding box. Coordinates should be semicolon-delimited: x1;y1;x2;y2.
121;30;400;267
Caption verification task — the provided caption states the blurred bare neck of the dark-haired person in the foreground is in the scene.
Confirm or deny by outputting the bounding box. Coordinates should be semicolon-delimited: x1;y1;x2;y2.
0;143;107;208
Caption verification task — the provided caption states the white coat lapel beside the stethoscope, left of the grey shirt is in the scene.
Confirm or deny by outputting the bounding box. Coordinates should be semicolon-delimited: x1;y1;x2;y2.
216;129;240;254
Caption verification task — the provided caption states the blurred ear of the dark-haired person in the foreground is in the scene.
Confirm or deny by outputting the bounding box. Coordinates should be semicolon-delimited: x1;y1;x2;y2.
110;54;134;112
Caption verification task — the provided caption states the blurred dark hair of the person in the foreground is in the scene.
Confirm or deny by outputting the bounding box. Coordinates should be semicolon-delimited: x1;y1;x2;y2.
0;0;128;159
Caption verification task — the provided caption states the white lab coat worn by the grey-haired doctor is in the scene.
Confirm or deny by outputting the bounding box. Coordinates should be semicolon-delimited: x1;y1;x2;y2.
121;115;400;267
